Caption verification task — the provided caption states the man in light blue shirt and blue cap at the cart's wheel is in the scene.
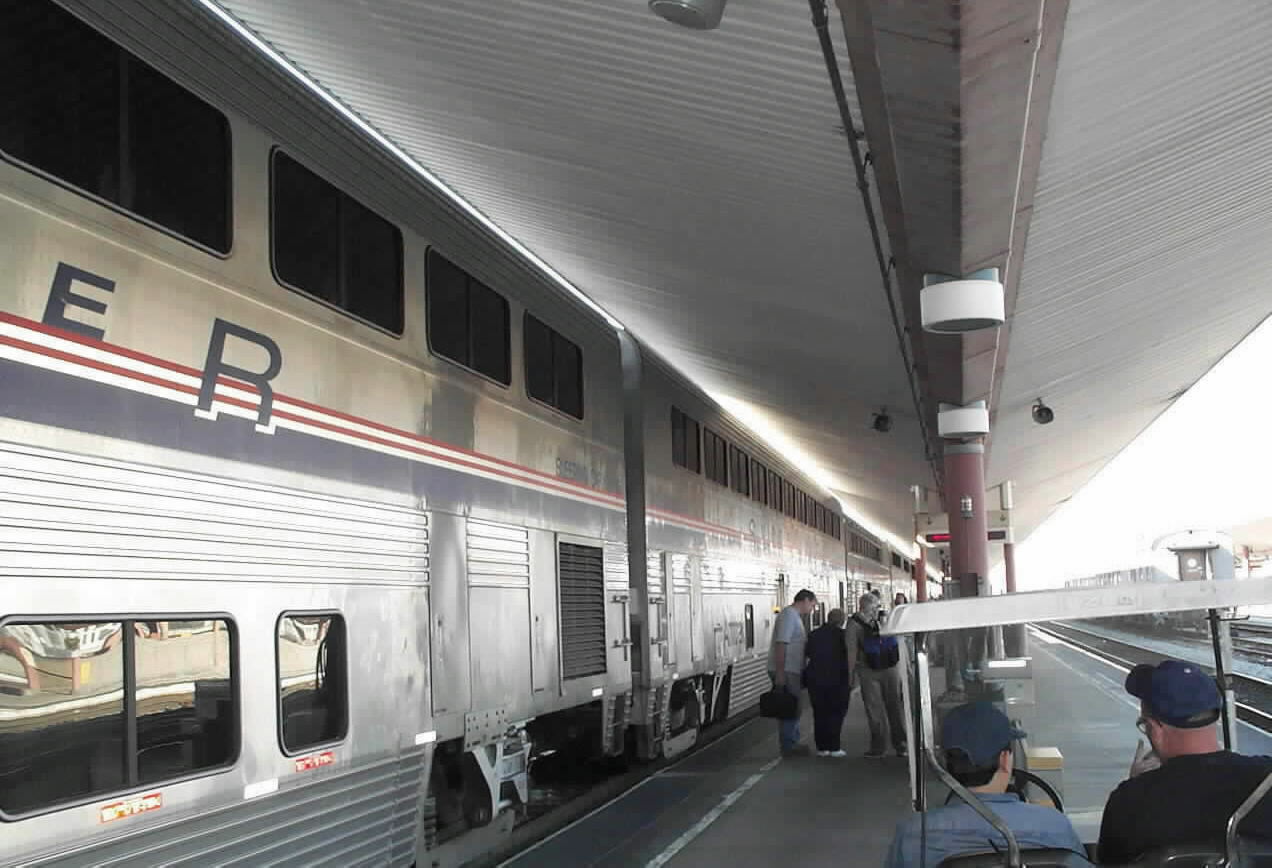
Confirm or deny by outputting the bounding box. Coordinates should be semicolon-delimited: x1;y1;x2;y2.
885;701;1086;868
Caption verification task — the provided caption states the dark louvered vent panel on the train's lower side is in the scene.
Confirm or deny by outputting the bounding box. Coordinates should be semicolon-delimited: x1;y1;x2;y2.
560;542;605;678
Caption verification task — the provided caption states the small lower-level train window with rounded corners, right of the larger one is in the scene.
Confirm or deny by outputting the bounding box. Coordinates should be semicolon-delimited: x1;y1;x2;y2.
277;612;349;753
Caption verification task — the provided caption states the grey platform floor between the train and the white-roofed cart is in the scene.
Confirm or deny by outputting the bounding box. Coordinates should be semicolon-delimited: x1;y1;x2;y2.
501;694;909;868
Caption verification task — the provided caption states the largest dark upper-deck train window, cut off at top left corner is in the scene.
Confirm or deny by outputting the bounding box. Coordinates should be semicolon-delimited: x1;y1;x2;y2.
0;0;232;253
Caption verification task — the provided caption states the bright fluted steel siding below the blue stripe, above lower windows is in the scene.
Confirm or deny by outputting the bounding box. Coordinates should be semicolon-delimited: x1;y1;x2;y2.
0;445;429;584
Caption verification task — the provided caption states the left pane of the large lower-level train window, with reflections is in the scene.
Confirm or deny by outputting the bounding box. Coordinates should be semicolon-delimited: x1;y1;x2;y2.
0;621;127;813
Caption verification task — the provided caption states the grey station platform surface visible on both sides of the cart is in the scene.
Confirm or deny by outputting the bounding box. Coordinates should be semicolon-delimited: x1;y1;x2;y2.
504;621;1272;868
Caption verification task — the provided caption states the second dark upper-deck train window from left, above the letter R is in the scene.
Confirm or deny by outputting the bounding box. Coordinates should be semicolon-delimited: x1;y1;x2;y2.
271;150;404;335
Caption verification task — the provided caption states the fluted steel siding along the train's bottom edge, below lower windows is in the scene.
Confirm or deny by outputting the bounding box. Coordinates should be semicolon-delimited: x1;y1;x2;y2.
29;752;424;868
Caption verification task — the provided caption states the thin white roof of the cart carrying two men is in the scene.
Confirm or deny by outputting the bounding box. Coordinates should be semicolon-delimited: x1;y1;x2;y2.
883;578;1272;634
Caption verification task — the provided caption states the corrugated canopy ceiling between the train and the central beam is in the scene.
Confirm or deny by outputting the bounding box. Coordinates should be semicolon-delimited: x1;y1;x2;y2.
223;0;930;537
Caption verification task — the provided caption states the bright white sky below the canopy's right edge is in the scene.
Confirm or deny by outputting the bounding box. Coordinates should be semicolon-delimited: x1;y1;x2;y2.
991;310;1272;591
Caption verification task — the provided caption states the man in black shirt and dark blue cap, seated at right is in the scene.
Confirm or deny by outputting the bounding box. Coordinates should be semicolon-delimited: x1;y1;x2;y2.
1099;661;1272;863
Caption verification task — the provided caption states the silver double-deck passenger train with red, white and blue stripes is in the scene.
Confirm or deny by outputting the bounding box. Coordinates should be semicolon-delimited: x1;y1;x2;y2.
0;0;912;867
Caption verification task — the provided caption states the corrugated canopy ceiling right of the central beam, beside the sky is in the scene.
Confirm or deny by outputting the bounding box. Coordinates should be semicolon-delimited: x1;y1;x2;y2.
990;0;1272;545
